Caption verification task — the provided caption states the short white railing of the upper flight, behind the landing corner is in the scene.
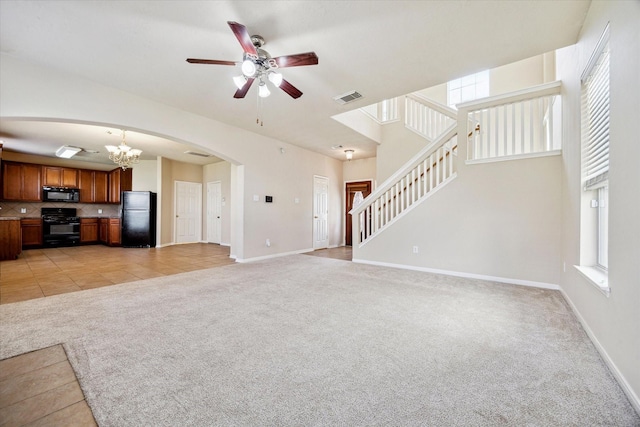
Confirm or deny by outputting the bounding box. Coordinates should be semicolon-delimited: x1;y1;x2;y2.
404;94;458;142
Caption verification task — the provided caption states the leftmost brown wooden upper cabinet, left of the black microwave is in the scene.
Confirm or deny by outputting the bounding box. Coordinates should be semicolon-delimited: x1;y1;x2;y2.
2;161;42;202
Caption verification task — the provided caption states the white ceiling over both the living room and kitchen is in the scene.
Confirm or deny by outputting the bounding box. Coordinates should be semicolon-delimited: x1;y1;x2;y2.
0;0;589;164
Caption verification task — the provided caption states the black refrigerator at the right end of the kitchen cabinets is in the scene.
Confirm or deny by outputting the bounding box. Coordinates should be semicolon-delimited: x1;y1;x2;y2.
120;191;156;248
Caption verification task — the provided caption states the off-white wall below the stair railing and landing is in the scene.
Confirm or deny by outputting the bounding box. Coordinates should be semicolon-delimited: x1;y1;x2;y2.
353;153;561;286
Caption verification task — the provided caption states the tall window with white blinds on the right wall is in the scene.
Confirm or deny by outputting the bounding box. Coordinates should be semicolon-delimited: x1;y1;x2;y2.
580;25;609;291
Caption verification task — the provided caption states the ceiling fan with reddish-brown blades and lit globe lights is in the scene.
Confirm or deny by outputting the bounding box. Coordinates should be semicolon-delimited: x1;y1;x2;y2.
187;21;318;99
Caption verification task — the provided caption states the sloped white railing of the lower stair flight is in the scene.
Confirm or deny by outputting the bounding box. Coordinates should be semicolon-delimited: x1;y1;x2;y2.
350;122;458;246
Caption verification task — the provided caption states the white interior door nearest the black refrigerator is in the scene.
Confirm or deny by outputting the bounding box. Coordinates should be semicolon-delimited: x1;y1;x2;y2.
174;181;202;243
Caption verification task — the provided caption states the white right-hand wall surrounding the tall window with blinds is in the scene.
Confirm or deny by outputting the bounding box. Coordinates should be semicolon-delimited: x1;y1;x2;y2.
556;1;640;412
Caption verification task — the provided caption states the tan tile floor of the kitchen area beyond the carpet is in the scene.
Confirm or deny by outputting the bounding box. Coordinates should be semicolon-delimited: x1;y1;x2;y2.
0;243;234;304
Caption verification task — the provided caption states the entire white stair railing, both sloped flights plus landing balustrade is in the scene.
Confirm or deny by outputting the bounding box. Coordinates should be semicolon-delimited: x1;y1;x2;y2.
350;82;561;247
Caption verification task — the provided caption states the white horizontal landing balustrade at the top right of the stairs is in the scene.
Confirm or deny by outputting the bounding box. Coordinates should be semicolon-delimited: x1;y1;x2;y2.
458;82;562;161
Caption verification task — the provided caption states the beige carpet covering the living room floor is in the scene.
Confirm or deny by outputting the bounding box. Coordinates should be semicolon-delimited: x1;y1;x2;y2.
0;255;640;426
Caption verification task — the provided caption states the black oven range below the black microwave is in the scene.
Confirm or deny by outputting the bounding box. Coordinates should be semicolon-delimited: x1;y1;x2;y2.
40;208;80;248
